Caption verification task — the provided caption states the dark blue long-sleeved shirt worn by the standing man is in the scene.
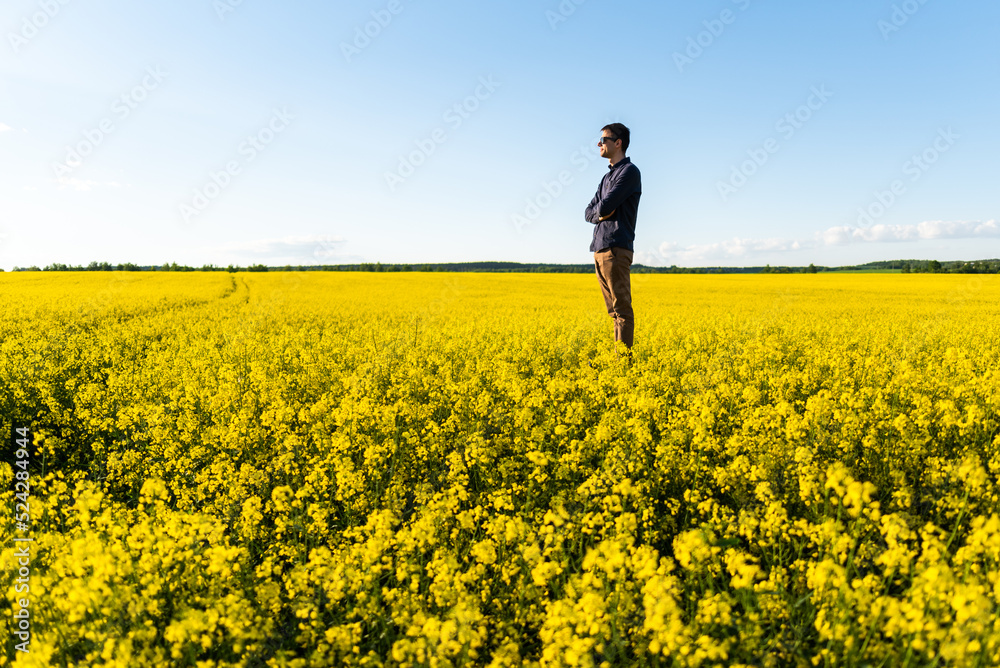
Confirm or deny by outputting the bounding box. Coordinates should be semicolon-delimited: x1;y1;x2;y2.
584;158;642;253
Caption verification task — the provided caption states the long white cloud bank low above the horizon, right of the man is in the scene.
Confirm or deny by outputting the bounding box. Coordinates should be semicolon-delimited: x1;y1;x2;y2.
652;220;1000;266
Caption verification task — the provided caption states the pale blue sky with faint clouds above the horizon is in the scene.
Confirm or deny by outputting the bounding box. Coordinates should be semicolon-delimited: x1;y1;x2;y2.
0;0;1000;270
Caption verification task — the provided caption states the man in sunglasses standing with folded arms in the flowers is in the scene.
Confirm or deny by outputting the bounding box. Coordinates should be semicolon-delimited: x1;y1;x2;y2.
585;123;642;364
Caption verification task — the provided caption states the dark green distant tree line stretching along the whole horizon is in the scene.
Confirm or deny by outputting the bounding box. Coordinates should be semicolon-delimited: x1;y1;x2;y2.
11;259;1000;274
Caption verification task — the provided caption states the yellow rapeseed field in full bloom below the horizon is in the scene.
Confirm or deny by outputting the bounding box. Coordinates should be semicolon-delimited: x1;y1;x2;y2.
0;272;1000;668
